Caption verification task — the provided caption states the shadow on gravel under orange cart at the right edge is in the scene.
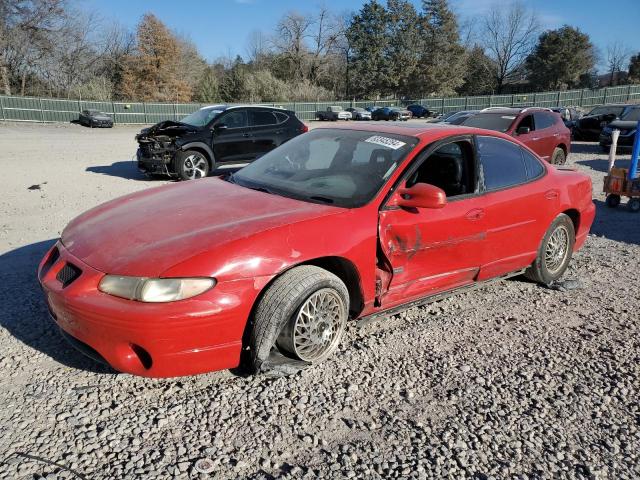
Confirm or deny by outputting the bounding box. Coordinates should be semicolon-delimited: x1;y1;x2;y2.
591;199;640;245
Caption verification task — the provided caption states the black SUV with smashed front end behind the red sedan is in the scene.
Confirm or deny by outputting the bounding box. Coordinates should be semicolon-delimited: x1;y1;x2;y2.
136;105;308;180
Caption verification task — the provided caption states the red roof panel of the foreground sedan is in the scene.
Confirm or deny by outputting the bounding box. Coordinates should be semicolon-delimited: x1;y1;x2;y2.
313;122;513;141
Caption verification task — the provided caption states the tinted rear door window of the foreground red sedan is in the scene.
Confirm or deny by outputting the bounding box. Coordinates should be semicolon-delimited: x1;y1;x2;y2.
477;136;529;191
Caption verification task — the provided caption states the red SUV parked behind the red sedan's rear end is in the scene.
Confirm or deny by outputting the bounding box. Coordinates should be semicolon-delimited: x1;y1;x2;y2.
463;107;571;165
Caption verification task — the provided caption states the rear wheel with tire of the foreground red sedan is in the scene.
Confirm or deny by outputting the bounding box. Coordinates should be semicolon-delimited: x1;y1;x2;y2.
524;213;576;285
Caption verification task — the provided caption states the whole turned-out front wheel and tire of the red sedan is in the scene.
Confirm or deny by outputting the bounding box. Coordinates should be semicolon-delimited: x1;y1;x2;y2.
248;265;349;373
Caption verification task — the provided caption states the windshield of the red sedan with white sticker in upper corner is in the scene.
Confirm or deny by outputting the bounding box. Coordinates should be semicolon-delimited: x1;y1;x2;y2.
231;129;418;208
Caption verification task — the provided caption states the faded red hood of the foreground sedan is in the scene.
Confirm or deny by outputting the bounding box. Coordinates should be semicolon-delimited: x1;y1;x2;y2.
62;178;342;277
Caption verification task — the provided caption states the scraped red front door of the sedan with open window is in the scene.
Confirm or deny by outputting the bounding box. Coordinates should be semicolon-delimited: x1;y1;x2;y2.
377;138;486;307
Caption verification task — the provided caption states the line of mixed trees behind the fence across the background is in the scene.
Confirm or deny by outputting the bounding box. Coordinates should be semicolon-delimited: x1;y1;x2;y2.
0;0;640;102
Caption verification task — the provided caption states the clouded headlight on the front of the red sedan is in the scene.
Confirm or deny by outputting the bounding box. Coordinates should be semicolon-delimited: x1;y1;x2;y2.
98;275;216;303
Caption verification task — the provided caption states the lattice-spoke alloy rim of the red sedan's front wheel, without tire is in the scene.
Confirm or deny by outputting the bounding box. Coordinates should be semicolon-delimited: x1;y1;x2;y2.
278;288;347;362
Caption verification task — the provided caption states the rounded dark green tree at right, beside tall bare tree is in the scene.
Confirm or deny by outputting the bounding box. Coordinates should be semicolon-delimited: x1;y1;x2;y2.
525;25;594;90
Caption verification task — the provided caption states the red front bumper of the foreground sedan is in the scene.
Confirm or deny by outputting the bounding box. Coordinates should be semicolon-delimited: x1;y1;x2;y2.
38;242;258;377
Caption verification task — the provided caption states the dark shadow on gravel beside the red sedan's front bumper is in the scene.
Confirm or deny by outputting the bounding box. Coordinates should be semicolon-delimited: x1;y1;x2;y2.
0;240;115;373
